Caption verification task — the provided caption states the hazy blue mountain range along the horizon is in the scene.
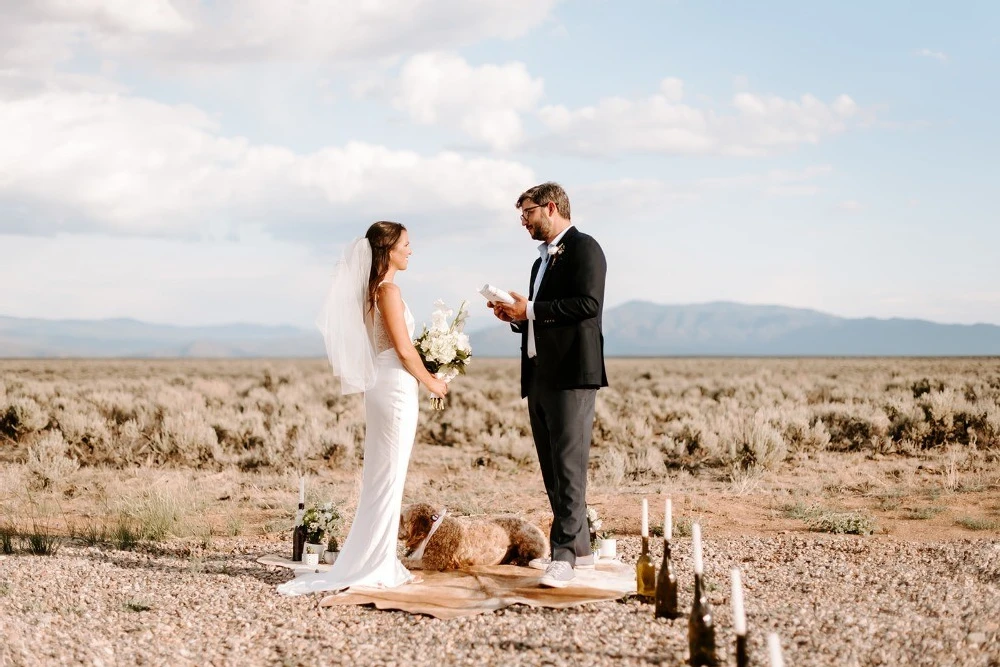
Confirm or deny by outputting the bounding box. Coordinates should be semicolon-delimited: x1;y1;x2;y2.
0;301;1000;357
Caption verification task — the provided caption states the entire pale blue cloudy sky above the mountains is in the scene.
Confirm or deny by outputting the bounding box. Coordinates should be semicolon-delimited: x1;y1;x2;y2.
0;0;1000;328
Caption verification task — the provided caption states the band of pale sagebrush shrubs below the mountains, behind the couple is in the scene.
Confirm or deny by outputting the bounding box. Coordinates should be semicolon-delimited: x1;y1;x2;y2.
0;359;1000;472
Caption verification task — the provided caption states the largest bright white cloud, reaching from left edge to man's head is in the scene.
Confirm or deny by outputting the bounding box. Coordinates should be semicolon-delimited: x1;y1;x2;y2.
0;92;534;236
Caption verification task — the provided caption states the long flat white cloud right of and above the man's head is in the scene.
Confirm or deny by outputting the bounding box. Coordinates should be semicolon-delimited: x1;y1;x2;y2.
539;79;865;156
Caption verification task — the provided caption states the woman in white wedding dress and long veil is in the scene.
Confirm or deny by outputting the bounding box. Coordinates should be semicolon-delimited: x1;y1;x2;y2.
278;221;448;595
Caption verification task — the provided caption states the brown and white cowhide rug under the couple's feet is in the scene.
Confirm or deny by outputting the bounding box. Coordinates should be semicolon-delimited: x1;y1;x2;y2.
257;555;635;618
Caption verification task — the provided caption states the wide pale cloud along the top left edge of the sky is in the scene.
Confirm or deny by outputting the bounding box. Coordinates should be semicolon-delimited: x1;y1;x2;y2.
0;0;558;66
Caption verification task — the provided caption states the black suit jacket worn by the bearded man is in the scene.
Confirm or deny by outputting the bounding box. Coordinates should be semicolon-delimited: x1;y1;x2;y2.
511;227;608;398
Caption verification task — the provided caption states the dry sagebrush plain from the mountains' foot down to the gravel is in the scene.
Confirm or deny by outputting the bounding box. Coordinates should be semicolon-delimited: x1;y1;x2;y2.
0;359;1000;548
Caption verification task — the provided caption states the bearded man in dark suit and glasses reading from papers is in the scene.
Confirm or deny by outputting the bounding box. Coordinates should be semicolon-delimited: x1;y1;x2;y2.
489;183;608;588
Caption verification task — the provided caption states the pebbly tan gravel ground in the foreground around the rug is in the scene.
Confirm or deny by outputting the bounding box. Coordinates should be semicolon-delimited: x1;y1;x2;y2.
0;534;1000;666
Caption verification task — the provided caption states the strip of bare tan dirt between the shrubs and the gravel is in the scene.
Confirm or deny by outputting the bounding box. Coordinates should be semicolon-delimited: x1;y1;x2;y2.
4;445;1000;541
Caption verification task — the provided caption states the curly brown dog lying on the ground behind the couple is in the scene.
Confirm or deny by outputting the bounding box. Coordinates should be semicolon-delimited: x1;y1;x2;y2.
399;503;549;570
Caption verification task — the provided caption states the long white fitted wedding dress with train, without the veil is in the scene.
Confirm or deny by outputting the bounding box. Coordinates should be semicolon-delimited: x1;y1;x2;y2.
278;302;418;595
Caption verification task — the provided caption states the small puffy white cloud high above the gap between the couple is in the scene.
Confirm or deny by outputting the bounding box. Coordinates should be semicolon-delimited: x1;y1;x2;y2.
385;52;544;150
